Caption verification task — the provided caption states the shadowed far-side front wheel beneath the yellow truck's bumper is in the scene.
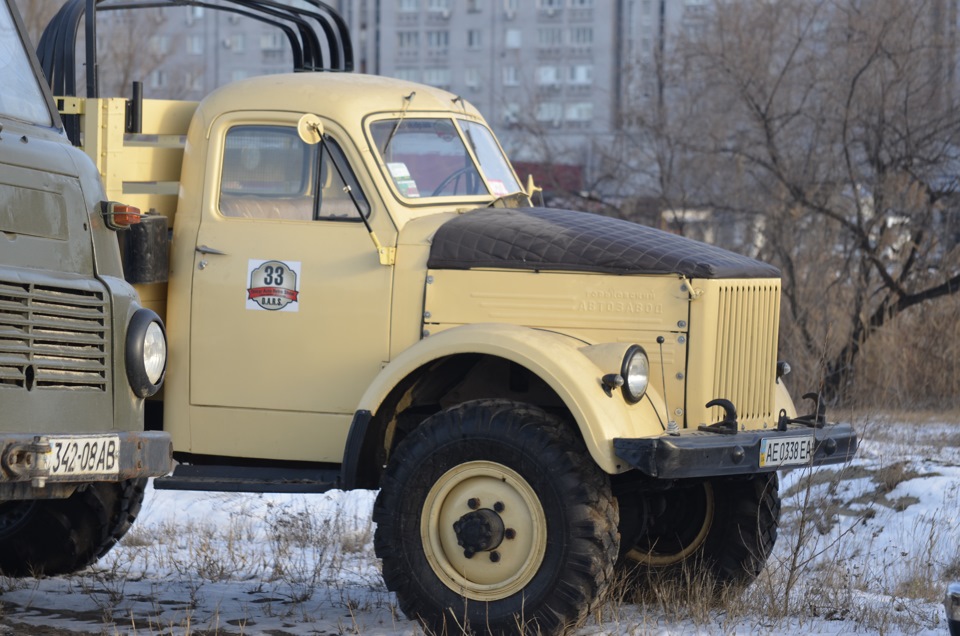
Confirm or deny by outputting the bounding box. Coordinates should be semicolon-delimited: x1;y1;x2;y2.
621;473;780;584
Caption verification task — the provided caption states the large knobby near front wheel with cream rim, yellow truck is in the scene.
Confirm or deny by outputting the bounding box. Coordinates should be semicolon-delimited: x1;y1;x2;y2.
373;400;619;634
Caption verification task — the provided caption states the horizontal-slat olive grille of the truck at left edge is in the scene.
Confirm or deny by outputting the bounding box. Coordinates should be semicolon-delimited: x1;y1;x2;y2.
0;281;109;391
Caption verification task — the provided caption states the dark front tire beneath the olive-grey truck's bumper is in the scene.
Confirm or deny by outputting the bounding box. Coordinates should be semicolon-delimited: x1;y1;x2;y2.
0;479;146;576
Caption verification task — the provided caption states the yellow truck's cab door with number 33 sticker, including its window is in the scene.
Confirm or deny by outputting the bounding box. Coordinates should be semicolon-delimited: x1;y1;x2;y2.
190;115;396;462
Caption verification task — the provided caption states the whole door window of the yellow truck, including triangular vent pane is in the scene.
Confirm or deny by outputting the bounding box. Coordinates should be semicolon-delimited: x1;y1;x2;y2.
219;126;370;221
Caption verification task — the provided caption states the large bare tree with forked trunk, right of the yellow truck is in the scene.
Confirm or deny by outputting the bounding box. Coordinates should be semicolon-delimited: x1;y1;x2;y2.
604;0;960;398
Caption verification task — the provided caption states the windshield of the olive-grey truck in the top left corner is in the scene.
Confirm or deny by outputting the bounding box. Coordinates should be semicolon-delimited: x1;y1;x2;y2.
0;0;52;126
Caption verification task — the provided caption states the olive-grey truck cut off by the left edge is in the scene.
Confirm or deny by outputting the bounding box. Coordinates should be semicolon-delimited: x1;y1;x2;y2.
0;0;172;576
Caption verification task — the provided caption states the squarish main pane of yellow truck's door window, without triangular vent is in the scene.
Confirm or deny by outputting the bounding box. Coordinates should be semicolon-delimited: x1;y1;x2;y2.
220;126;317;221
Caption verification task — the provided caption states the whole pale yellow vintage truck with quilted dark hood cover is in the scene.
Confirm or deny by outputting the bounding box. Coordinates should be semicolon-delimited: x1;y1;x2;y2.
40;0;857;633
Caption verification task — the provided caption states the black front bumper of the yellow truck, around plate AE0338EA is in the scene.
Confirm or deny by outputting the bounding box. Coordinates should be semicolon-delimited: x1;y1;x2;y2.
613;424;857;479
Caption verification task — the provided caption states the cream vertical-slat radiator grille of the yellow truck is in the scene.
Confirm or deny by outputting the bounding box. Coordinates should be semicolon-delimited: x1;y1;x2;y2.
711;281;780;422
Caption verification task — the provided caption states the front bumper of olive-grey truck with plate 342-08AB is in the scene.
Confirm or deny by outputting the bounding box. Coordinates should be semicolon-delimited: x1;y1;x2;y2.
0;431;173;490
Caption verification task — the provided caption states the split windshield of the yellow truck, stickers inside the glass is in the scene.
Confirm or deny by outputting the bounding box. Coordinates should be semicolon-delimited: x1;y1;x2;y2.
370;118;520;199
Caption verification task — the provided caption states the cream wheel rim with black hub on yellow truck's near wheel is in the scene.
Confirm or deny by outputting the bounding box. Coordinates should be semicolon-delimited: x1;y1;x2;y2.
420;461;547;601
